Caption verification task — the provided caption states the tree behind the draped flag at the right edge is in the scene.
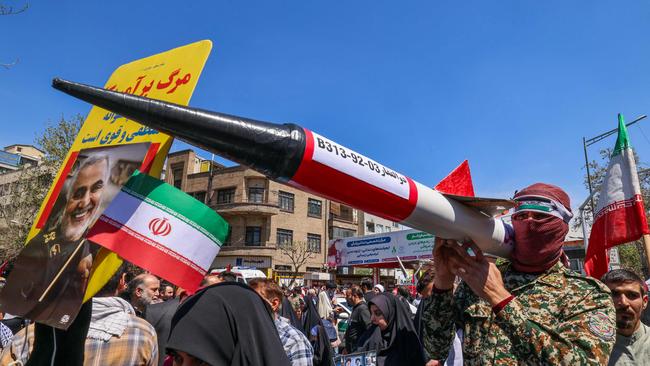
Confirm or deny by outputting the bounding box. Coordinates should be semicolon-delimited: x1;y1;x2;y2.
575;148;650;278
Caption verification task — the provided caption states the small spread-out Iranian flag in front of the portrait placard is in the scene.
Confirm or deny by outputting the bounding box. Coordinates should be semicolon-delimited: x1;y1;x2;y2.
87;171;228;292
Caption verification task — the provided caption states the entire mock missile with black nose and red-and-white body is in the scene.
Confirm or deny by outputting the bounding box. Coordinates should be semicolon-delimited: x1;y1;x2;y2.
52;79;511;257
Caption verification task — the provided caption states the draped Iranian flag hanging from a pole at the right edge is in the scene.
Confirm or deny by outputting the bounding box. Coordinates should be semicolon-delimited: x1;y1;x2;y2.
585;114;650;278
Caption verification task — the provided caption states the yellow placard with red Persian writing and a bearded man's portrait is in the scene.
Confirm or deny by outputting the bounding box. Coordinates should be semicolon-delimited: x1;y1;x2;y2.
0;40;212;329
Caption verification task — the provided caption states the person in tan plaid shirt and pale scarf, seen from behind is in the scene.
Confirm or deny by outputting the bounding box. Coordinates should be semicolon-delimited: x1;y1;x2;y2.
0;264;159;366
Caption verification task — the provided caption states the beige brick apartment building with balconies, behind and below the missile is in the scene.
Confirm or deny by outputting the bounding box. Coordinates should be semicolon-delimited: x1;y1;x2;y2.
165;150;342;279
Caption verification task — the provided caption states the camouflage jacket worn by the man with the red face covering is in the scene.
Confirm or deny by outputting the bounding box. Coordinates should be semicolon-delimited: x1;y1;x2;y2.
422;263;616;365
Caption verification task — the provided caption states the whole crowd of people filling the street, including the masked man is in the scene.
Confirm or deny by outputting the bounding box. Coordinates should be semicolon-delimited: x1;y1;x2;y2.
0;184;650;366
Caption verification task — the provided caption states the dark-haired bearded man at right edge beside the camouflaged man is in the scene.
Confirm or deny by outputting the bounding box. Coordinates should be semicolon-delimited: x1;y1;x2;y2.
601;269;650;365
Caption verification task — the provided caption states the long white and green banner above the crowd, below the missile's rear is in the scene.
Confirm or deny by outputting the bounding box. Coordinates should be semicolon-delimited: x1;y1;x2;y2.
327;230;435;267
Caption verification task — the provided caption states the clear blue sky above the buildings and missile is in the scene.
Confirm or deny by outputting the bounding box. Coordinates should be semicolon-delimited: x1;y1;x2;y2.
0;0;650;207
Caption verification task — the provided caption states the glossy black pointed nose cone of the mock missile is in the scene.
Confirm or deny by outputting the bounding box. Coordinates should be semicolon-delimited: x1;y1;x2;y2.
52;78;305;181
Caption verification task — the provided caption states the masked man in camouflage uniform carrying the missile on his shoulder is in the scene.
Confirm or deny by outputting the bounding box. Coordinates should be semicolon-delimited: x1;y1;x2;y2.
422;183;616;365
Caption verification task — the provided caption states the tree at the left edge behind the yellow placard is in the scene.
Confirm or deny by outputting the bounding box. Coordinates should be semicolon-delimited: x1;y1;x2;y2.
0;115;83;261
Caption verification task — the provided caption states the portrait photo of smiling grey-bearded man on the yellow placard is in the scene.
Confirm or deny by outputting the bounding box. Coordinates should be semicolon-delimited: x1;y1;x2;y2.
0;142;150;329
